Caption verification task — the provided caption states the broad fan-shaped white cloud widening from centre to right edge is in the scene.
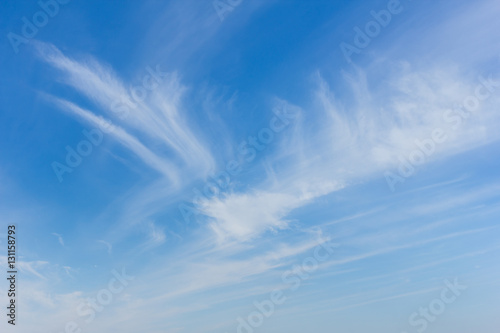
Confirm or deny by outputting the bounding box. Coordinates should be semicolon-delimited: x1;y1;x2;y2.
202;62;500;240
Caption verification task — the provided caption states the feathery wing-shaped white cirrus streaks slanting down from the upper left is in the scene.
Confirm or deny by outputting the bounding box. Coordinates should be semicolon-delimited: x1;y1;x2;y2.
35;42;214;183
